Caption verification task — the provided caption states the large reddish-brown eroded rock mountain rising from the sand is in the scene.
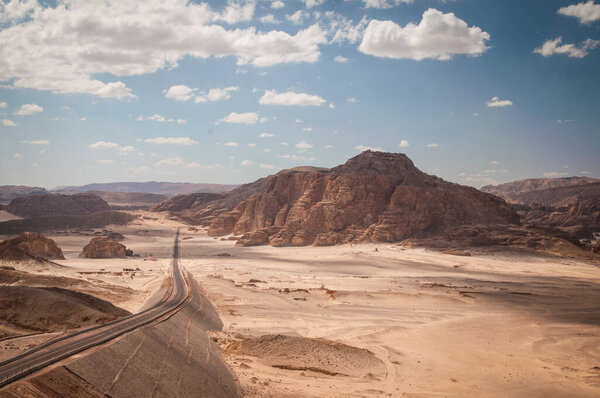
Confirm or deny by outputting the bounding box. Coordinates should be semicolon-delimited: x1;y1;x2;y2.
208;151;519;246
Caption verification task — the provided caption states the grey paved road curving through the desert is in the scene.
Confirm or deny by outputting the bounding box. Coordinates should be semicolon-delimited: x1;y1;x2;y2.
0;230;189;387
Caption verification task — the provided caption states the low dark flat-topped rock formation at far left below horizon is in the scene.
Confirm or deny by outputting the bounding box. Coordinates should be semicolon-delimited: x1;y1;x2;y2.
8;193;110;218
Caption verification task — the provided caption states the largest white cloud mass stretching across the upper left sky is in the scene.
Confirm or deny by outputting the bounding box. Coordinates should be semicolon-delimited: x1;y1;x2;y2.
0;0;327;99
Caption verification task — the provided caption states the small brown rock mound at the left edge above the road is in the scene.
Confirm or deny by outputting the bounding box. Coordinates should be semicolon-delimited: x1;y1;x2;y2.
0;232;65;261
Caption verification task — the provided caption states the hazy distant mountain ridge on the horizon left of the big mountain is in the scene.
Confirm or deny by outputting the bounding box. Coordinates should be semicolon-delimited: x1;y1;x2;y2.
54;181;237;196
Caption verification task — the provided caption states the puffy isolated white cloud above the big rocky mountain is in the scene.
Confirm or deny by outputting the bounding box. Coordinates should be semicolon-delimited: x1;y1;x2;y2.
358;8;490;61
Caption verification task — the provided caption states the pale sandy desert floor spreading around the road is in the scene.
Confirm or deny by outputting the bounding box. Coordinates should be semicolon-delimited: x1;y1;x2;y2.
0;213;600;397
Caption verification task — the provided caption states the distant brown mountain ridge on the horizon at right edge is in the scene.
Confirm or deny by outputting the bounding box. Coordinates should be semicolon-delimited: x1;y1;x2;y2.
481;177;600;204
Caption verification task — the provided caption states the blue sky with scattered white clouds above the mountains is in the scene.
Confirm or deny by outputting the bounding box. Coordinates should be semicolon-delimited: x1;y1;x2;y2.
0;0;600;188
